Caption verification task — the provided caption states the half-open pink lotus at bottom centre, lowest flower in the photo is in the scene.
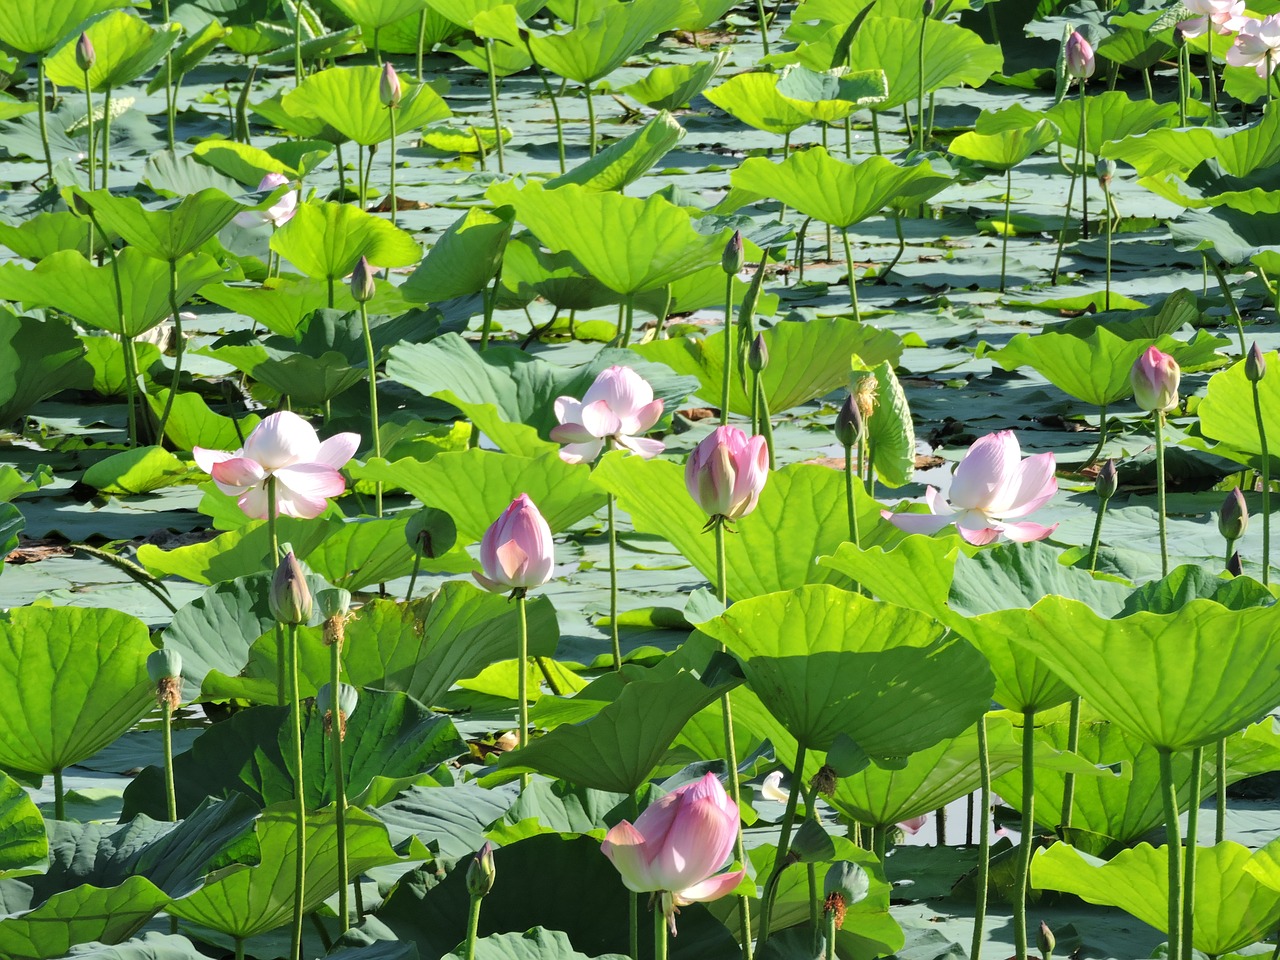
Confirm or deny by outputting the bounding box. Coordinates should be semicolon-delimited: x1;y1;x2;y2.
600;773;746;933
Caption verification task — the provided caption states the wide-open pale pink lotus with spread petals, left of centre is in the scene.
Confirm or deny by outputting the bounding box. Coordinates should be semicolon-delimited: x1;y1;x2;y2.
192;411;360;520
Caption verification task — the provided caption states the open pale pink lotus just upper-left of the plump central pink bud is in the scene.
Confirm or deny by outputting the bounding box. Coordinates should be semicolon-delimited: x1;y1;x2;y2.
552;366;663;463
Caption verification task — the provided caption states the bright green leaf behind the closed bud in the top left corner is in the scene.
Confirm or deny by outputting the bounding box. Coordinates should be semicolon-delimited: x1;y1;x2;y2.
45;10;182;93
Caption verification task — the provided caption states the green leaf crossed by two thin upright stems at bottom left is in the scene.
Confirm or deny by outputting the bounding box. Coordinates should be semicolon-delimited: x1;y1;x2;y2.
169;803;399;938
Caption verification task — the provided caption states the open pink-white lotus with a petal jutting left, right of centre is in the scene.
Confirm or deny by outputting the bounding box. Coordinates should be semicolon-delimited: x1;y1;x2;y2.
883;430;1057;545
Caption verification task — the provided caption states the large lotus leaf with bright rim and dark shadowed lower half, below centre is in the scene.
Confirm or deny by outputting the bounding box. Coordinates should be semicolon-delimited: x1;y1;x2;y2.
699;585;993;758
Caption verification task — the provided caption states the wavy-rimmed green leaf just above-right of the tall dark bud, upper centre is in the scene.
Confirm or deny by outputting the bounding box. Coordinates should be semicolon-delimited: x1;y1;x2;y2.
730;147;952;228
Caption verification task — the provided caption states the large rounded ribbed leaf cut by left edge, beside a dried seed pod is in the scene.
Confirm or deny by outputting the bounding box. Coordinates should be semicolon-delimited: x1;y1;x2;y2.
0;607;155;774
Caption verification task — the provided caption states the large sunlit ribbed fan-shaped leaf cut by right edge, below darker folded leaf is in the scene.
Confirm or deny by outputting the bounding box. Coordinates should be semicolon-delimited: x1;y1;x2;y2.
977;596;1280;750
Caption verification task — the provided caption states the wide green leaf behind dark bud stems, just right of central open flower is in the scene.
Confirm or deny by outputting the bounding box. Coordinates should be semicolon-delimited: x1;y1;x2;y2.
632;316;902;416
